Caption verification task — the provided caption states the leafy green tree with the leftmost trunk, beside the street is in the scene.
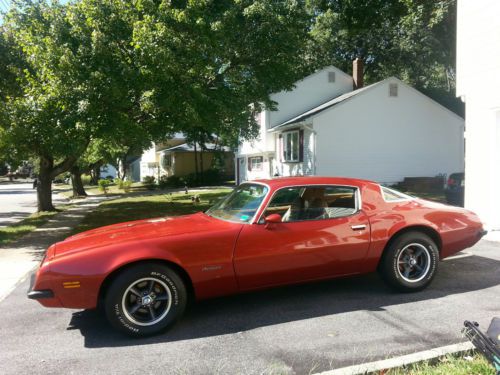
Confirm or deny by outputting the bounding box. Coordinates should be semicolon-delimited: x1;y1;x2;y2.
0;0;160;211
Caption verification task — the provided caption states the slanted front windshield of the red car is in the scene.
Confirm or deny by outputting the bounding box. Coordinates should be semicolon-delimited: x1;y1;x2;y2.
206;184;268;223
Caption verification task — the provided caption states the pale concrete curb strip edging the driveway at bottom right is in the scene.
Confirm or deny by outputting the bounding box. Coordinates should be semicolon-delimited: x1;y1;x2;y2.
314;341;474;375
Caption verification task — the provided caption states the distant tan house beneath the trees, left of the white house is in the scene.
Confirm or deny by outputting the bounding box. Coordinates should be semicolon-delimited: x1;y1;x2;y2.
140;133;234;180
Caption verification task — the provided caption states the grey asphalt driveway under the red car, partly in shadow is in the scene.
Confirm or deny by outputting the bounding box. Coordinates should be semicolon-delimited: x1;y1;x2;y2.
0;241;500;374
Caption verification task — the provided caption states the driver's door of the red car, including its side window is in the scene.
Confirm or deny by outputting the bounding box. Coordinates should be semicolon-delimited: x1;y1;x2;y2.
234;186;370;290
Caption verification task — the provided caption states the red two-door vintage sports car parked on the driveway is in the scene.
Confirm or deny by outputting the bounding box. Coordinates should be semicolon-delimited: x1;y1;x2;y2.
28;177;485;336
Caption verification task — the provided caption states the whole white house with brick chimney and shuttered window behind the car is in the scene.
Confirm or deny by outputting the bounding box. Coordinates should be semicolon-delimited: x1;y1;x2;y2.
236;60;464;187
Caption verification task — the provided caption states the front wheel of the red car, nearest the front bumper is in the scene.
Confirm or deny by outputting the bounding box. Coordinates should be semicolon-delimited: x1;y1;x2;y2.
104;263;187;337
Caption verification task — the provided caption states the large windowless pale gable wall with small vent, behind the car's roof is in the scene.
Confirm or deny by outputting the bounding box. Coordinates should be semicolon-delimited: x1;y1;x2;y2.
314;79;464;183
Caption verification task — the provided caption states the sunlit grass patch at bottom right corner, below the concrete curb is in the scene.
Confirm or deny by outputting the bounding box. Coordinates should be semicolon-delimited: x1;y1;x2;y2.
384;354;495;375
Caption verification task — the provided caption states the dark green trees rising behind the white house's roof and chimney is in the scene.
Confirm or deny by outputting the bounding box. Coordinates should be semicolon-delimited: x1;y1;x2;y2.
308;0;463;115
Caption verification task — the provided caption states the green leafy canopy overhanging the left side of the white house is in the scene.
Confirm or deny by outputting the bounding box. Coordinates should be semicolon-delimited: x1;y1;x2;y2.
134;0;311;146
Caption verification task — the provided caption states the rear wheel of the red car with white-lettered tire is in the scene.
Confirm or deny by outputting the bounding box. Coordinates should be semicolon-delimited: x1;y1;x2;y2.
379;232;439;292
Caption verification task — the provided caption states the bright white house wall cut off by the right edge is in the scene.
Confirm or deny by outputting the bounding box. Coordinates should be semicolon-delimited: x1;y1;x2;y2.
457;0;500;234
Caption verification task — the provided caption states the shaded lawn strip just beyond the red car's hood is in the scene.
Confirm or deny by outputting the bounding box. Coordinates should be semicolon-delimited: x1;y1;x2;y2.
73;189;231;233
